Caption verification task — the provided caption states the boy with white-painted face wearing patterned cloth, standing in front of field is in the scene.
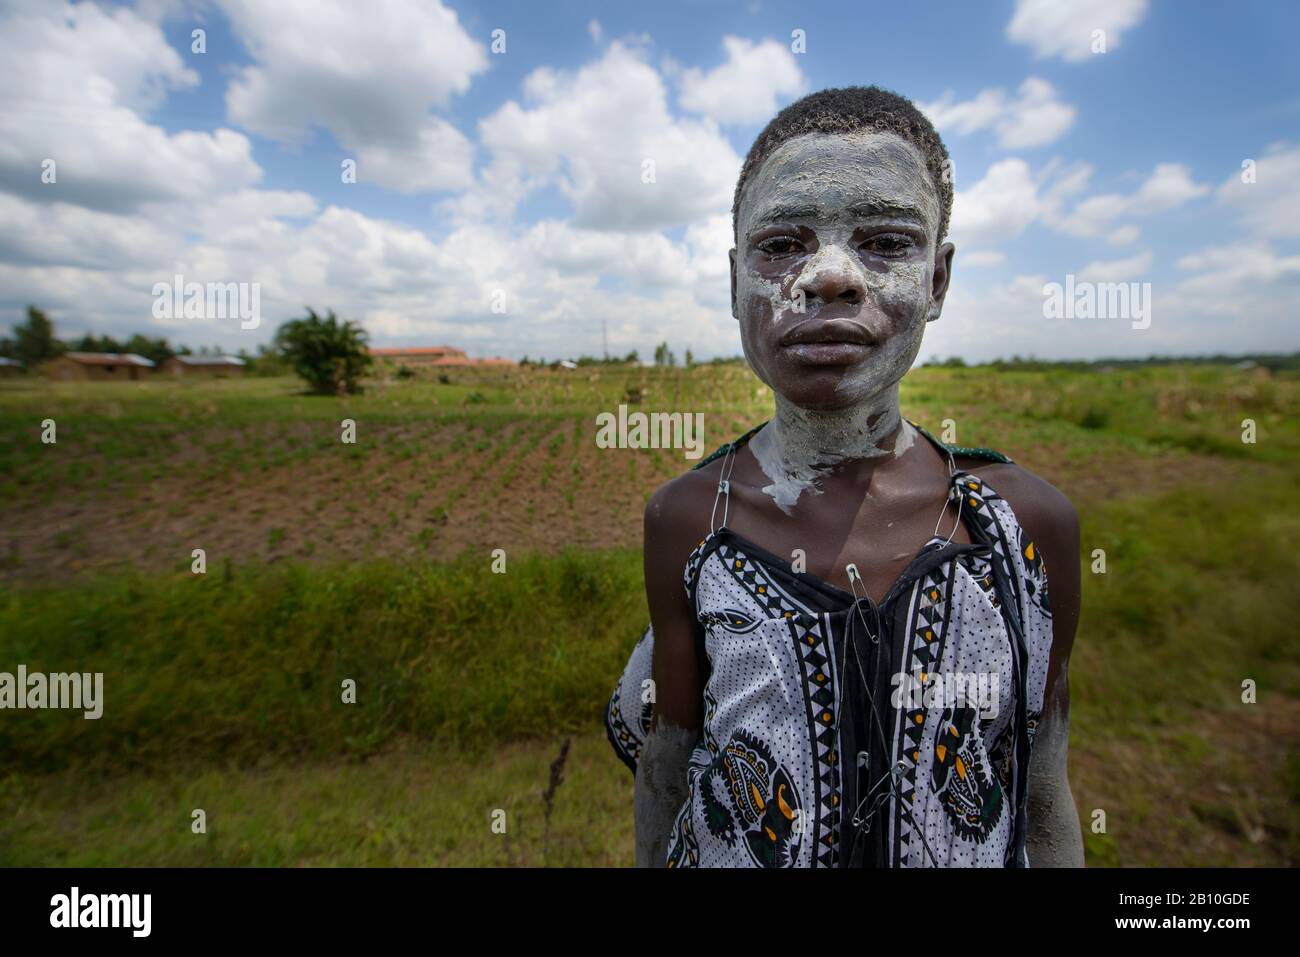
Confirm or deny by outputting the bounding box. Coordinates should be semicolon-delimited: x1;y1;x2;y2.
607;87;1083;867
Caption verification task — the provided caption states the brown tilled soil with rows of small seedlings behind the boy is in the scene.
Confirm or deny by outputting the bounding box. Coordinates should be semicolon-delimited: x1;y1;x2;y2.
0;429;1260;581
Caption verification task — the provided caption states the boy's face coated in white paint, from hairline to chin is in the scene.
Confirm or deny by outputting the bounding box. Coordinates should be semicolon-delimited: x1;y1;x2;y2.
731;131;953;410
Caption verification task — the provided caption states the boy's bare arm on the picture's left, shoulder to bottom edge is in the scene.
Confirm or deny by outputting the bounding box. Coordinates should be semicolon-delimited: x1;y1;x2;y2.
634;476;707;867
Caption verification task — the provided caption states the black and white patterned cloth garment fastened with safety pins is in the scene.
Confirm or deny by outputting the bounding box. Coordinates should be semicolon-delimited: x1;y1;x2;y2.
606;426;1052;867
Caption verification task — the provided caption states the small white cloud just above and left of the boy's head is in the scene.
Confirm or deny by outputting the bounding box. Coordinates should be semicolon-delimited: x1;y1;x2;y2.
679;36;807;124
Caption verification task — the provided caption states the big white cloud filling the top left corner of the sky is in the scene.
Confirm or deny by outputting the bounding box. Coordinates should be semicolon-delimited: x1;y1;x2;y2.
0;4;261;212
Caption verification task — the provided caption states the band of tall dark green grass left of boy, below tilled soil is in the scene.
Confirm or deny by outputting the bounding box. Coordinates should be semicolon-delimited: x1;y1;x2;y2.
0;551;646;771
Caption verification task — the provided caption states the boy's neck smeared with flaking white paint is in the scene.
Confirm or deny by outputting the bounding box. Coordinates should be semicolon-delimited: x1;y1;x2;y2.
749;384;915;515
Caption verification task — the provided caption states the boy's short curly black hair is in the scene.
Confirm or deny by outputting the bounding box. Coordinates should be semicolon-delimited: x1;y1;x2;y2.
732;86;953;241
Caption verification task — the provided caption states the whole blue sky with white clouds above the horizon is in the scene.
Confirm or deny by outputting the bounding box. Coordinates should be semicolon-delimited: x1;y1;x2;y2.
0;0;1300;360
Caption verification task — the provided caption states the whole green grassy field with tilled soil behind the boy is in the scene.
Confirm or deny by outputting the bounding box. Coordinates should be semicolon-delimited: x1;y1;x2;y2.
0;365;1300;866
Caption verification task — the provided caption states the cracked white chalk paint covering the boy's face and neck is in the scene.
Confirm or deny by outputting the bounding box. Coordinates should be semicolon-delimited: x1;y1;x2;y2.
736;133;940;514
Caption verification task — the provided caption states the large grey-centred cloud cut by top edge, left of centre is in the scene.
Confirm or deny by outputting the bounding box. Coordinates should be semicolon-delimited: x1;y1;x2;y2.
218;0;488;192
